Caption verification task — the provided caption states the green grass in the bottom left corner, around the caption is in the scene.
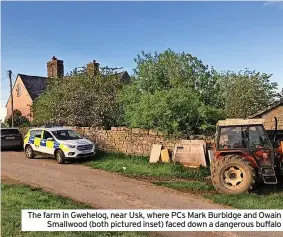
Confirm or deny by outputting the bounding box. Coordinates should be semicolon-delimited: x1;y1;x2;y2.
1;184;148;237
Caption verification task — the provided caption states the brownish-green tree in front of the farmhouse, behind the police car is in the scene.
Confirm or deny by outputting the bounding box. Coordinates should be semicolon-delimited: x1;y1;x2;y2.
32;66;123;127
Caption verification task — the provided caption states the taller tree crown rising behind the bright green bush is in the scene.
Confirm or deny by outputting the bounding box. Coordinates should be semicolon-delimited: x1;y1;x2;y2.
134;49;223;107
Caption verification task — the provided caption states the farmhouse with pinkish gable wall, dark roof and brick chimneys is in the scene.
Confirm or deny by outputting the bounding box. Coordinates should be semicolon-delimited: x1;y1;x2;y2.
6;56;130;121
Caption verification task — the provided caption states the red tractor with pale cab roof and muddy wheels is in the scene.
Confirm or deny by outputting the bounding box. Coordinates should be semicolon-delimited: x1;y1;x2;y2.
211;118;283;194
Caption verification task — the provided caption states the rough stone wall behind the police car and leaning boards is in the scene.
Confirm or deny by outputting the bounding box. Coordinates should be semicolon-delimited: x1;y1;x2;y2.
19;127;213;156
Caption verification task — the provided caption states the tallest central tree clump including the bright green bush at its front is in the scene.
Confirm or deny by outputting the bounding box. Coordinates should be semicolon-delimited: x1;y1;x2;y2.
119;49;226;135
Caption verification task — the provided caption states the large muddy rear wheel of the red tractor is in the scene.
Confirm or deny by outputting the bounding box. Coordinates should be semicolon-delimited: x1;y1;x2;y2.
211;154;255;194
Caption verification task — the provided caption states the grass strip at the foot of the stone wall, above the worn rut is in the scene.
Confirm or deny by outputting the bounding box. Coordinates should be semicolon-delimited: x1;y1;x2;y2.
85;152;209;180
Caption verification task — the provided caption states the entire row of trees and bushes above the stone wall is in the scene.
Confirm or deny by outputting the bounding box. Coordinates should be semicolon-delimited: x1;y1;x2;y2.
32;49;283;136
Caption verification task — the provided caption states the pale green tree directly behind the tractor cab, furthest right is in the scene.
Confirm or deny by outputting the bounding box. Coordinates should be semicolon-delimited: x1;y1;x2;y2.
221;69;278;118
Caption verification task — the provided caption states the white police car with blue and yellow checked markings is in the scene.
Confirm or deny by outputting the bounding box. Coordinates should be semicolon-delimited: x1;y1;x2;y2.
24;127;95;164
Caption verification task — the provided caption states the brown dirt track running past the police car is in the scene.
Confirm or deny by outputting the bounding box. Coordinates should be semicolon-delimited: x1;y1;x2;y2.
1;151;283;237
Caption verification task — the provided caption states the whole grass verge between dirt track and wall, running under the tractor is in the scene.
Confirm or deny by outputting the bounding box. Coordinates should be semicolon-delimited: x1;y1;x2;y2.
81;152;283;209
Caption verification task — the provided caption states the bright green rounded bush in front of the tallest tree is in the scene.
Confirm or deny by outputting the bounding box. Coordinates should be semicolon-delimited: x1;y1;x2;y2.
122;88;200;135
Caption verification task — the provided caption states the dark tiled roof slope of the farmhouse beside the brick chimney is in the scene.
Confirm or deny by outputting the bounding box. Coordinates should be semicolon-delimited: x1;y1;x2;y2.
18;74;47;100
